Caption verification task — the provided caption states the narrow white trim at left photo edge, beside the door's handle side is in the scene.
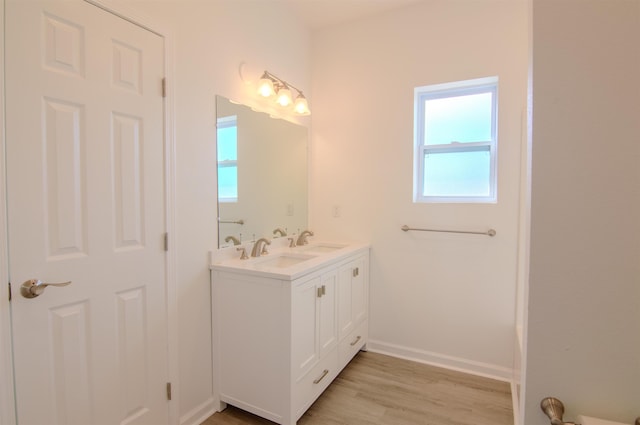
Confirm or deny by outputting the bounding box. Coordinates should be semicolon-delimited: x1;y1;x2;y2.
0;0;17;425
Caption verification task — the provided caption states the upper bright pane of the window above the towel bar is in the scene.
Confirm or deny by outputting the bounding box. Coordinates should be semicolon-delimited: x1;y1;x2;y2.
424;92;493;145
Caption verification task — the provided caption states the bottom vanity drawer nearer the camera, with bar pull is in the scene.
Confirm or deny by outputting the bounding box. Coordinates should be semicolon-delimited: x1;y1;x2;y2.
293;349;338;419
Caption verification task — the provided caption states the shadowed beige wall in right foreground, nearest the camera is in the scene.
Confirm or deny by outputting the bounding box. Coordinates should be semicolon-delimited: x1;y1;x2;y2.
524;0;640;425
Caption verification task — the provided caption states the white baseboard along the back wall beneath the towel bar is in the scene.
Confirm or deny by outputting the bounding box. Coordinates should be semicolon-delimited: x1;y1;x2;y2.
367;340;513;382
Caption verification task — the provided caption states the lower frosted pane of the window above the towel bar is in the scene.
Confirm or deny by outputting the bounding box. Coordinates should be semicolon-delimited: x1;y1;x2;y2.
422;147;491;197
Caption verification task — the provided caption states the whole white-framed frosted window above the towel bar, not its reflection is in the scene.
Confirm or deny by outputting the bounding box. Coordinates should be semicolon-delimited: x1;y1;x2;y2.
414;77;498;202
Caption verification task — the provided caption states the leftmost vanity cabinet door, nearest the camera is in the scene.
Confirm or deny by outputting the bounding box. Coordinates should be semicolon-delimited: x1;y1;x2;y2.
291;276;322;378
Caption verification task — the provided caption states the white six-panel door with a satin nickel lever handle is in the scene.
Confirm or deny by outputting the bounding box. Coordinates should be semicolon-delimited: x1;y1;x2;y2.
5;0;168;425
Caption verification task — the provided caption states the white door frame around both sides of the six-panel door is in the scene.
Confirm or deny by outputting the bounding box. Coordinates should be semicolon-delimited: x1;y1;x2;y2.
0;0;180;425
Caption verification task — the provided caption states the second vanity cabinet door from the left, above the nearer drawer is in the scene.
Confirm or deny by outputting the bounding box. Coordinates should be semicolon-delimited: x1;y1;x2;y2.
316;270;338;357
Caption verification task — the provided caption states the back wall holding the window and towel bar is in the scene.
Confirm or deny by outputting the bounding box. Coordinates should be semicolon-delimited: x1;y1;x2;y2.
312;1;527;379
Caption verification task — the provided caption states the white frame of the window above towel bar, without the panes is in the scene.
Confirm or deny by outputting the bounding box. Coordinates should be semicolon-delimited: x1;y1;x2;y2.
413;77;498;203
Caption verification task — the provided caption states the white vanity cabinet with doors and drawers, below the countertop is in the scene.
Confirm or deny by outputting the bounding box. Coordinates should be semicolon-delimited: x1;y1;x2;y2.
212;247;369;425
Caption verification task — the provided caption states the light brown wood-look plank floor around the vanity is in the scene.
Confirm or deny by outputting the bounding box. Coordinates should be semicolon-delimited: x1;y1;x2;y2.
203;352;513;425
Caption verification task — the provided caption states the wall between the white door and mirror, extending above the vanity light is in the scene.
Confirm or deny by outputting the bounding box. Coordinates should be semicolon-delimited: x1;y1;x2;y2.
119;0;313;423
